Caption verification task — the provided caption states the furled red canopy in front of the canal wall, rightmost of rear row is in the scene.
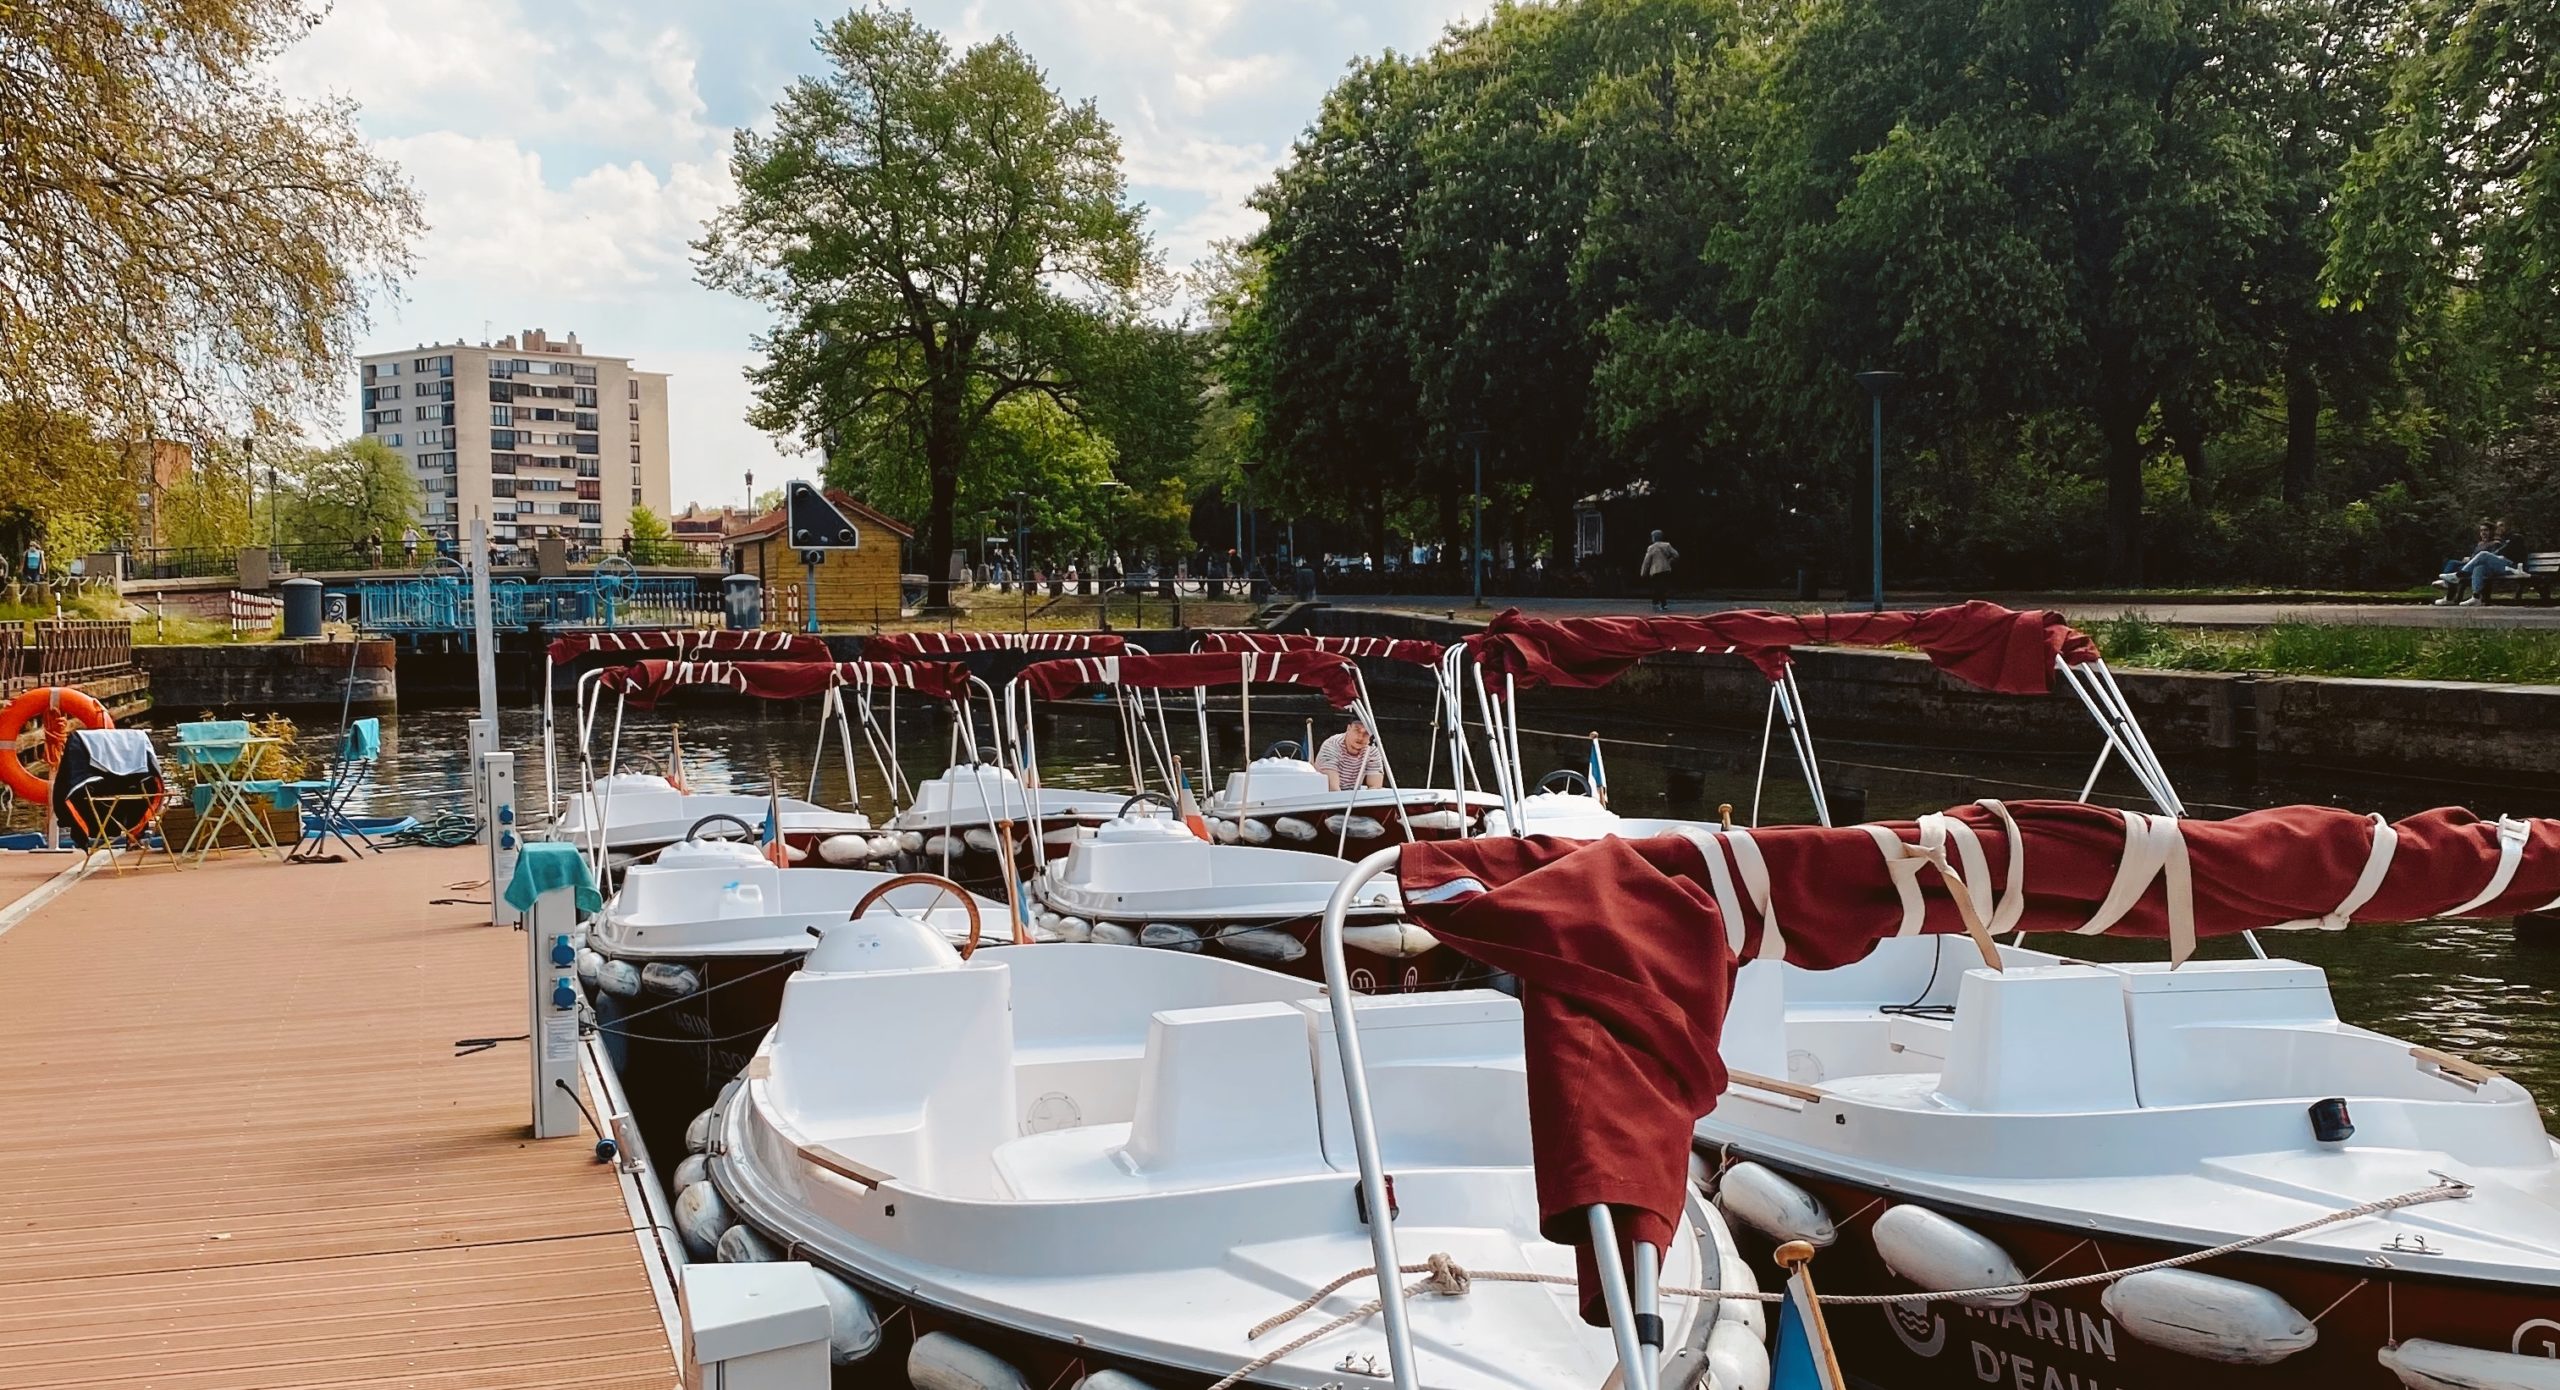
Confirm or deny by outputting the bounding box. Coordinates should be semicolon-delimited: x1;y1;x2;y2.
1467;599;2097;694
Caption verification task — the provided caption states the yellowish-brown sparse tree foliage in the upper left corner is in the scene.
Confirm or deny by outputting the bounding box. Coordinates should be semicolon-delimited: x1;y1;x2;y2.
0;0;422;438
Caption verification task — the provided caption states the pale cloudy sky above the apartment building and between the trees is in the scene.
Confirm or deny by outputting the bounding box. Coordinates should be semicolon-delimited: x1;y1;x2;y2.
276;0;1487;509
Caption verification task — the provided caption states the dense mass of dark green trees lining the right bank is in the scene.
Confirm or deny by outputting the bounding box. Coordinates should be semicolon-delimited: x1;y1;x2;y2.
1228;0;2560;591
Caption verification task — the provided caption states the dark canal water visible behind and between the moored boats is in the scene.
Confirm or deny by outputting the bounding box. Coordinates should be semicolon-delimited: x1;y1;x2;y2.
275;699;2560;1121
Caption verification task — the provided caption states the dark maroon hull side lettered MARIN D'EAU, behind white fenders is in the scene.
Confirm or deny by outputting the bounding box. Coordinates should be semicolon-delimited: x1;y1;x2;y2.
1708;1147;2560;1390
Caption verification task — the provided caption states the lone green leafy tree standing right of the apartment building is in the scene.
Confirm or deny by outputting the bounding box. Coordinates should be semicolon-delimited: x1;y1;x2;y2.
696;10;1155;599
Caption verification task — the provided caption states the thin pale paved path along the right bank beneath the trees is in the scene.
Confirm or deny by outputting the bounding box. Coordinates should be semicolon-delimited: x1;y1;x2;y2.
1326;594;2560;632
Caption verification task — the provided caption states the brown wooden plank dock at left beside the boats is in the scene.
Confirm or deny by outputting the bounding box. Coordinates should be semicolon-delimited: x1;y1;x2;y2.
0;850;678;1390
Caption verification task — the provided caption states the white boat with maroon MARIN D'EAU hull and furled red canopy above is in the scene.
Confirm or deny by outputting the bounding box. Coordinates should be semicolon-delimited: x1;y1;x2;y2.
1395;801;2560;1390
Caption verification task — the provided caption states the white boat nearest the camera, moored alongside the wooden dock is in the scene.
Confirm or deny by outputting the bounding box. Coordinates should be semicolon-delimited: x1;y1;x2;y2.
676;916;1769;1390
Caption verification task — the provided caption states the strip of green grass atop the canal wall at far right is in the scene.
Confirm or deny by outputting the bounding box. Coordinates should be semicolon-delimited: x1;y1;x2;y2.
2089;614;2560;686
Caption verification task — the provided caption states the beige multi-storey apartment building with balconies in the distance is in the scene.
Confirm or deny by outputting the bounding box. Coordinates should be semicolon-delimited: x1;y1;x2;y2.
361;328;668;550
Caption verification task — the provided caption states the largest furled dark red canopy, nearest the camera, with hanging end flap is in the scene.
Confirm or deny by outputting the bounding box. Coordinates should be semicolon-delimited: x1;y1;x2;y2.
1395;801;2560;1316
